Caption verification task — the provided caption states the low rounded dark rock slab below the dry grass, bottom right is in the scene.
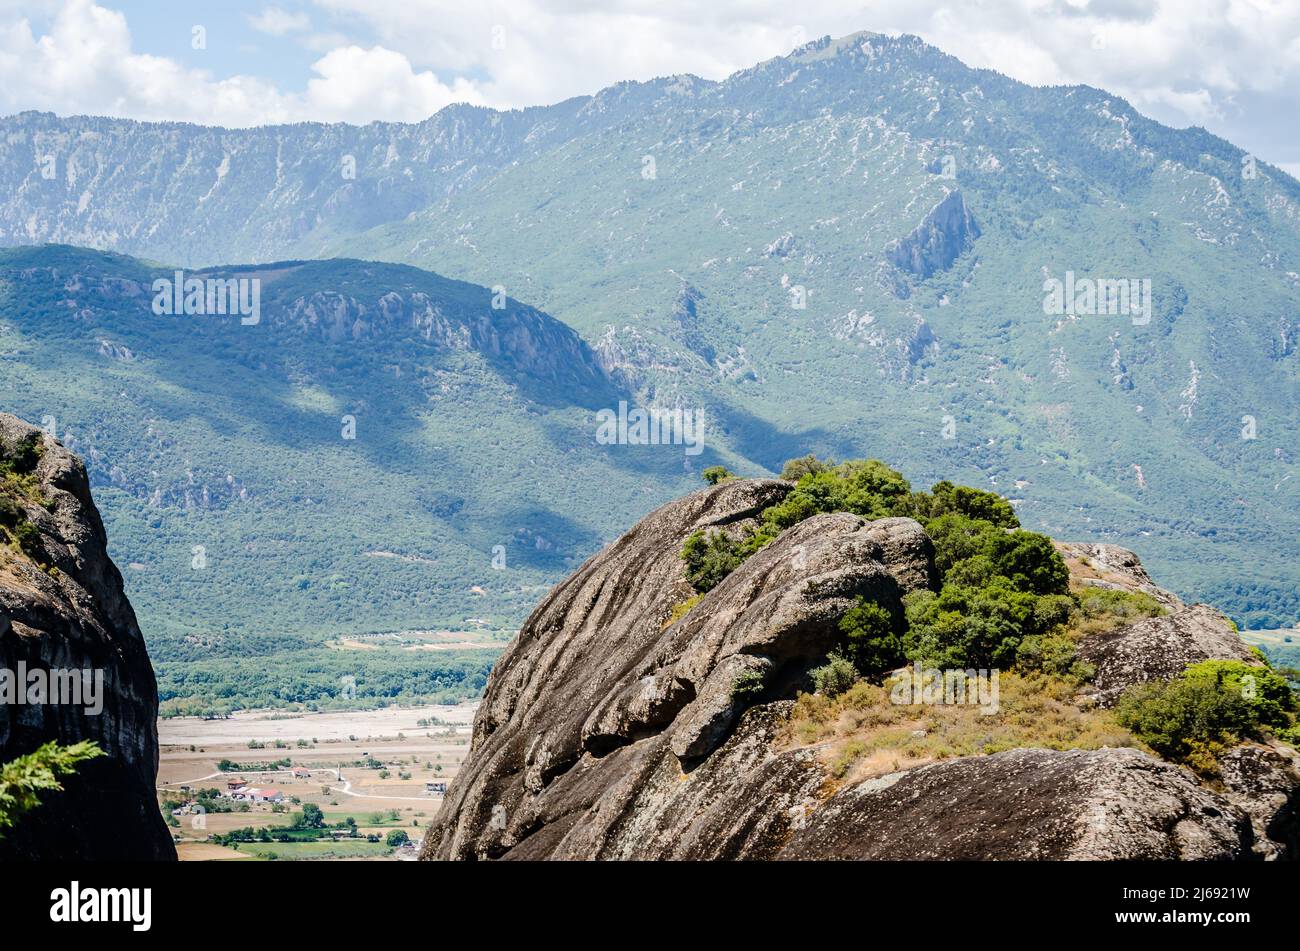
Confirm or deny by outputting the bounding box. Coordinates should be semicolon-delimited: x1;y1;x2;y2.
779;750;1252;859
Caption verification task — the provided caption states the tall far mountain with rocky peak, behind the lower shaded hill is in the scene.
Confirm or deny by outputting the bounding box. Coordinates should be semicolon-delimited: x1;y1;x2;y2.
0;34;1300;628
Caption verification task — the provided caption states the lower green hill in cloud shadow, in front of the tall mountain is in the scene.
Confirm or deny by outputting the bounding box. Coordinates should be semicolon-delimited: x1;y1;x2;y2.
0;246;712;700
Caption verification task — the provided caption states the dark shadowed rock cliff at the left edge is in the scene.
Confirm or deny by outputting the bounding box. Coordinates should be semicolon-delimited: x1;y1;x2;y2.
0;413;176;860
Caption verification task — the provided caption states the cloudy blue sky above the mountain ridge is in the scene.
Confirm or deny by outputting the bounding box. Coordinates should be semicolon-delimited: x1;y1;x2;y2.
0;0;1300;177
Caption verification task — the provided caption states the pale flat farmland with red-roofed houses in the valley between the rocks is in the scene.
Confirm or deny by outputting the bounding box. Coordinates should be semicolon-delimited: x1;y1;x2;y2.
159;703;476;861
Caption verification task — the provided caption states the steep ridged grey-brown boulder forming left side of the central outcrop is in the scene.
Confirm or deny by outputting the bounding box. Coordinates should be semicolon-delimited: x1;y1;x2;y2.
424;481;933;857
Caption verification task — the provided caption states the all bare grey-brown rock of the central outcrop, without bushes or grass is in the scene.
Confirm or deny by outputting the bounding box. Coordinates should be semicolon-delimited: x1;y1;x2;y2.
423;481;1300;859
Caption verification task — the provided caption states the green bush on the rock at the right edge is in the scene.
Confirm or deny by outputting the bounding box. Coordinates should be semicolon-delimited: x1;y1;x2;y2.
1115;660;1300;773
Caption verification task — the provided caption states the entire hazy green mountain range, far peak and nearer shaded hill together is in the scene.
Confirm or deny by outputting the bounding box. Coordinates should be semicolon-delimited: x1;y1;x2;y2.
0;34;1300;711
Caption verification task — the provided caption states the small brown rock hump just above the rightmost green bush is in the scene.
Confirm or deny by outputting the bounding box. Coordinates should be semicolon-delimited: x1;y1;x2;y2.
1078;604;1260;707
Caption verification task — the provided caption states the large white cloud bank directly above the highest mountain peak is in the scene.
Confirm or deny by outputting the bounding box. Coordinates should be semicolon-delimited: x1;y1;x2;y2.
304;0;1300;140
